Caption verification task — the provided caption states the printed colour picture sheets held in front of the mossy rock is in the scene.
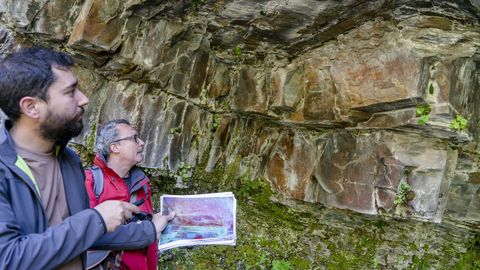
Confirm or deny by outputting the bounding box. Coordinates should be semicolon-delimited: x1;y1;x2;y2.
158;192;237;251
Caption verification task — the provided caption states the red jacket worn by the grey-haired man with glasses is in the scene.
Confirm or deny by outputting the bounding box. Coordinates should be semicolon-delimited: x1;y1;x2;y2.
85;155;158;270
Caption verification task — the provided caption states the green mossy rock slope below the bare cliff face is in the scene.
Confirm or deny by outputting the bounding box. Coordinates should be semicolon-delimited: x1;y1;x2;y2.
152;169;478;269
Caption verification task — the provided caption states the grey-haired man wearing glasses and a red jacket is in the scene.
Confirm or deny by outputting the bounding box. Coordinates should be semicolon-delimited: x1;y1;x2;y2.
85;119;158;270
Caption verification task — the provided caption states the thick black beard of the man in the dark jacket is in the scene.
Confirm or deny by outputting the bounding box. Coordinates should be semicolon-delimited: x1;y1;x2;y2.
40;109;83;146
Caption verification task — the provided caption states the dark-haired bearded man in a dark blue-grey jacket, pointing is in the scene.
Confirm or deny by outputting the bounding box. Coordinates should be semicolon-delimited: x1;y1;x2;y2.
0;48;173;269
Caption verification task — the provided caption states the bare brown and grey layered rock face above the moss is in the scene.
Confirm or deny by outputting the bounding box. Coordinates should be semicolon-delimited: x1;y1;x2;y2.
0;0;480;226
